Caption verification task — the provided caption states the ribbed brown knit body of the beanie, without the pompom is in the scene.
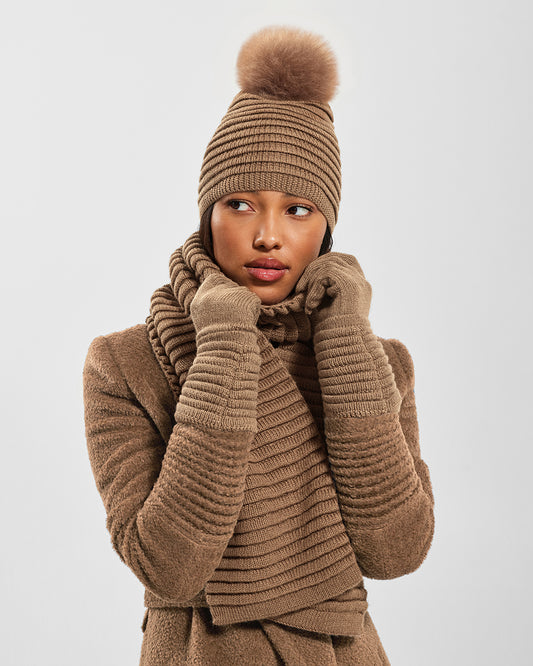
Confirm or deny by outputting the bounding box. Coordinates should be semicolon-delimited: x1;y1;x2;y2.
198;92;341;232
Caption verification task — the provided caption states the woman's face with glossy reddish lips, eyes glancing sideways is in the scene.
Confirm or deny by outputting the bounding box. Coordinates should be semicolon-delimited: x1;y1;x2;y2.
211;190;327;305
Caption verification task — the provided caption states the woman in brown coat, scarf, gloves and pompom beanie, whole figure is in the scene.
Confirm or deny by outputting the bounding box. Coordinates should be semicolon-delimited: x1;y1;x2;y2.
84;28;434;666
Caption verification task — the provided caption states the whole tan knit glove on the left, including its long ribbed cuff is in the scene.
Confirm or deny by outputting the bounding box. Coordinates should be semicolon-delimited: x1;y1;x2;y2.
175;273;261;433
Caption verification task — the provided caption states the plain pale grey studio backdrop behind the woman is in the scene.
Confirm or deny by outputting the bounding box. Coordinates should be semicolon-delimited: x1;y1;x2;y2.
0;0;533;666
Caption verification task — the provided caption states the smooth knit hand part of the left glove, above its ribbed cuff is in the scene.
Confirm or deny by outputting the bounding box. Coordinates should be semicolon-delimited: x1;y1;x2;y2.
190;271;261;332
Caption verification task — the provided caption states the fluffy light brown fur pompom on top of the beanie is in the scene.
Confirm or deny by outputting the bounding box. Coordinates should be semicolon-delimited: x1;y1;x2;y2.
237;26;338;103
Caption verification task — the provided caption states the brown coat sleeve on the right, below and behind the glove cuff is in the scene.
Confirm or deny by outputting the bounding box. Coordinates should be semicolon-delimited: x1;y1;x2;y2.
327;339;435;579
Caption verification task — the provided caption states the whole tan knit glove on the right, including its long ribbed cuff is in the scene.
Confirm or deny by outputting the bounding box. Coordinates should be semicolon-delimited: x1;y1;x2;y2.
298;252;401;422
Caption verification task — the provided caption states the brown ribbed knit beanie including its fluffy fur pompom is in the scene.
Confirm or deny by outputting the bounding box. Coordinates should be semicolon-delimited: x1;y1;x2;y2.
198;27;341;232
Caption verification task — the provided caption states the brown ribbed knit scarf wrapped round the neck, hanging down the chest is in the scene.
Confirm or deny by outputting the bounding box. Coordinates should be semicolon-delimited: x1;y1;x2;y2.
146;231;368;635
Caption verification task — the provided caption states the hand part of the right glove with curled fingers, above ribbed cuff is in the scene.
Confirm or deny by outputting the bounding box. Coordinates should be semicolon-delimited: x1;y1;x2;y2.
295;252;372;325
